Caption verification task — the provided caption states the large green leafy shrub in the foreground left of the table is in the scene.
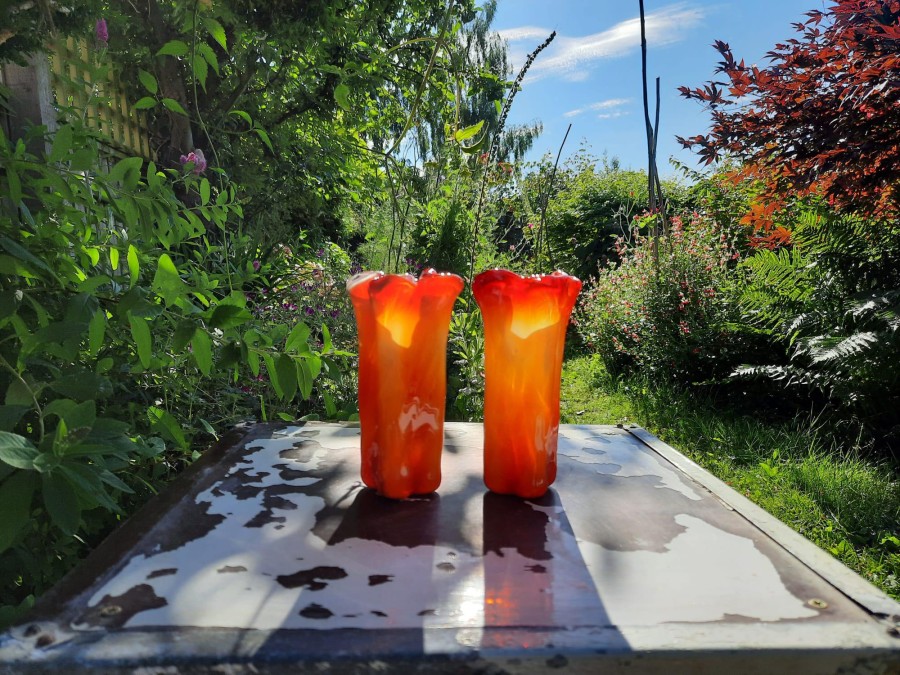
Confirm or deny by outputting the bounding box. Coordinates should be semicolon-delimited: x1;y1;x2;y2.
0;117;346;618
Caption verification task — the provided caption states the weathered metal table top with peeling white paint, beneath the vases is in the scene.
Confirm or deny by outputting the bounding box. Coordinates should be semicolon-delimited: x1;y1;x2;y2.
0;423;900;672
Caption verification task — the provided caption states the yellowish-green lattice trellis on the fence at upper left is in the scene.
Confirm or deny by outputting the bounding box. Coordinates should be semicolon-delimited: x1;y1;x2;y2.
51;38;156;159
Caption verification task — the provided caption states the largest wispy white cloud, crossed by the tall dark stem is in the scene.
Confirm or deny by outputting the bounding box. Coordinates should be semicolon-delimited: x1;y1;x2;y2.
500;2;705;81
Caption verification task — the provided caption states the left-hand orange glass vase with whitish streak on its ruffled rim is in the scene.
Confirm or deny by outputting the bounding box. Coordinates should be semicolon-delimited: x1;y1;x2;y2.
347;270;463;499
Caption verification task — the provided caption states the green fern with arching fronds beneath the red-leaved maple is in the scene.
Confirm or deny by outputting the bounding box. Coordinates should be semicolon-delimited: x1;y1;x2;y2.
736;207;900;443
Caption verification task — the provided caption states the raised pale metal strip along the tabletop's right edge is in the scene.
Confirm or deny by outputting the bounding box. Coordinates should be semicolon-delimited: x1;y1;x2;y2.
624;425;900;627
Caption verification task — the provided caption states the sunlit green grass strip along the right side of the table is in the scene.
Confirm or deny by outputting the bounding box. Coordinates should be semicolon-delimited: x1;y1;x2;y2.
561;356;900;600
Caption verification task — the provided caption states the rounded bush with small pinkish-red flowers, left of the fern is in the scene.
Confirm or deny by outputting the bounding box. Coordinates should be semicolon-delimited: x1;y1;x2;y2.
575;212;741;382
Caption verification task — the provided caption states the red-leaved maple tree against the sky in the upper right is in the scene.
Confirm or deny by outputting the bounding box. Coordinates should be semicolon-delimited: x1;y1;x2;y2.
678;0;900;218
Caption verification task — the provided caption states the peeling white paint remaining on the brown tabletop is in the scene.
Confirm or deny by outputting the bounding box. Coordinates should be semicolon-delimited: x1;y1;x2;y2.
75;425;816;636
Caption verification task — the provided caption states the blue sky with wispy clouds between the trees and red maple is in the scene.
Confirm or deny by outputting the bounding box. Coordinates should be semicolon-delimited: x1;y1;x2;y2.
493;0;824;176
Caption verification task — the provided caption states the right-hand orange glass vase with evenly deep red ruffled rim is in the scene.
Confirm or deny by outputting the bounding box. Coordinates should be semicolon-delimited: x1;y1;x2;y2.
472;270;581;498
